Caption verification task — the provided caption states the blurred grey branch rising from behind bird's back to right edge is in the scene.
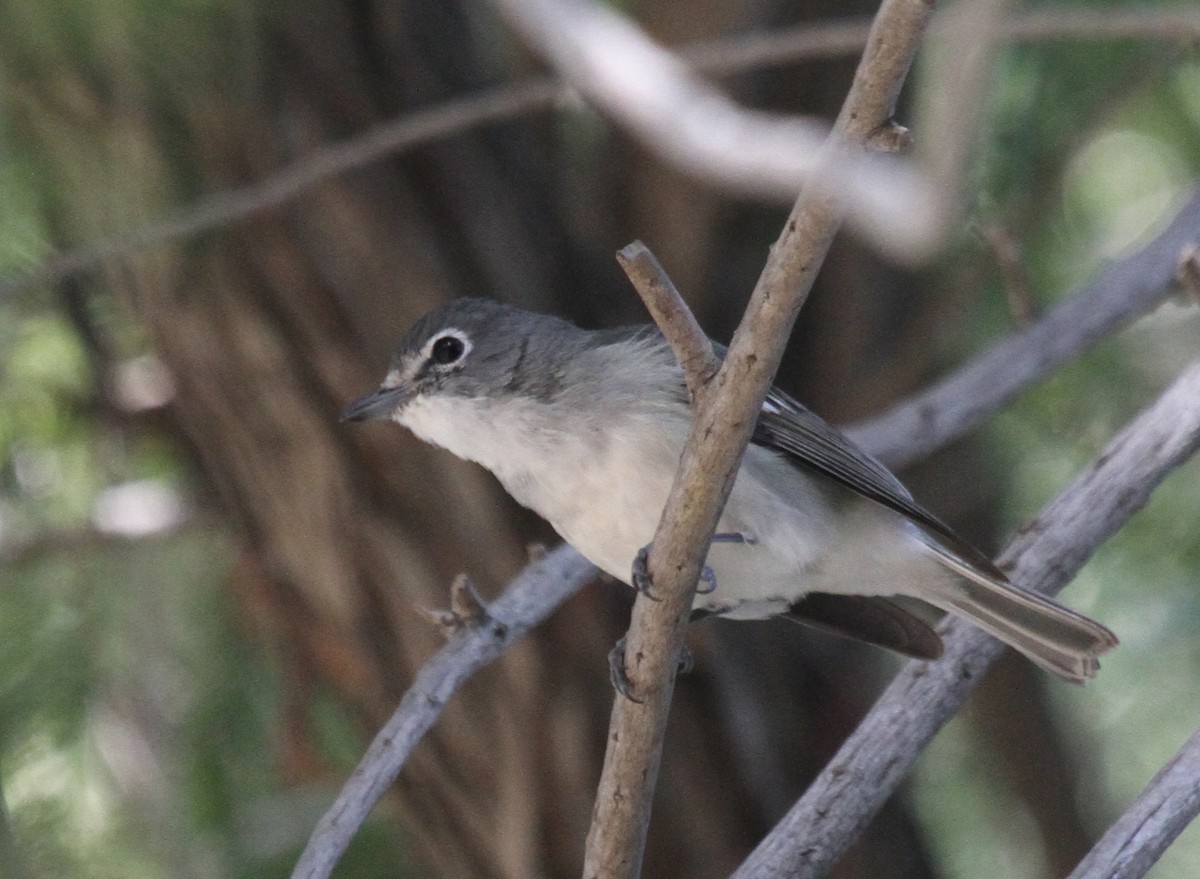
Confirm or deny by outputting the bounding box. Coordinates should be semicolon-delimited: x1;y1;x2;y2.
846;191;1200;467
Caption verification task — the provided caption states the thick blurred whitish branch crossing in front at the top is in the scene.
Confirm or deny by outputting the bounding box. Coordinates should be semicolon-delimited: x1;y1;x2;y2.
484;0;936;259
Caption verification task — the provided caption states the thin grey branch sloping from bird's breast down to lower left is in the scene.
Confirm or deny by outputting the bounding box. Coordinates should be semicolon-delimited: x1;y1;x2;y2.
292;546;596;879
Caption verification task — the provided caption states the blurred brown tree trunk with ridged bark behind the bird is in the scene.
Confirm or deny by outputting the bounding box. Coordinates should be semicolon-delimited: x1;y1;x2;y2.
9;0;1094;879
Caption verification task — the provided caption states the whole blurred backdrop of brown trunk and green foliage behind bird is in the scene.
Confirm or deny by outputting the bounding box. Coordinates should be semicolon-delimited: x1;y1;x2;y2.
0;0;1200;879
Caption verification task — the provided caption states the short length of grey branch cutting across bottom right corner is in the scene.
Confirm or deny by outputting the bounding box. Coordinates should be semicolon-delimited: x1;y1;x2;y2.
1069;731;1200;879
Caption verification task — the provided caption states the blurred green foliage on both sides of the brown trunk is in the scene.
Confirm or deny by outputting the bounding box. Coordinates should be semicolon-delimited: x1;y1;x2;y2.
0;0;1200;879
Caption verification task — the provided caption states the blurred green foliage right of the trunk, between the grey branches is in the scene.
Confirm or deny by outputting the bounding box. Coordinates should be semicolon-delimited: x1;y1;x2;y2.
912;17;1200;879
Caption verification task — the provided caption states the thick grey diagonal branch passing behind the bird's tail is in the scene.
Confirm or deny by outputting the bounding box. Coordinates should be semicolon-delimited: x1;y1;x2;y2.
734;363;1200;879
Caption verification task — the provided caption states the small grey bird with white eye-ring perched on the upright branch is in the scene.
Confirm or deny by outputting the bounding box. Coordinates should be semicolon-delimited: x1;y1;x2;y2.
342;298;1117;683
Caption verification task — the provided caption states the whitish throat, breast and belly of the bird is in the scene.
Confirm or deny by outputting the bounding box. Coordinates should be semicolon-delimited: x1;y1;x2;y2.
400;397;921;617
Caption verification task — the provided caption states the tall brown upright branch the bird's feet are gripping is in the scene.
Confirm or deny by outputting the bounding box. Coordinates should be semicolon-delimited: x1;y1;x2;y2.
583;0;932;878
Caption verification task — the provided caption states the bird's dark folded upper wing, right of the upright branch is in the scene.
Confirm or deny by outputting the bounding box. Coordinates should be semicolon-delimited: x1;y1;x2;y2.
751;388;1008;582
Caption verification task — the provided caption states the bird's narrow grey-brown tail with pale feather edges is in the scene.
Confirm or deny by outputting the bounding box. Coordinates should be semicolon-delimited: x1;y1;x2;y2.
929;554;1117;683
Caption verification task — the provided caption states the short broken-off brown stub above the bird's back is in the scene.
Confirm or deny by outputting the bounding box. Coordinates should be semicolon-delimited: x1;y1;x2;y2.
617;241;721;401
